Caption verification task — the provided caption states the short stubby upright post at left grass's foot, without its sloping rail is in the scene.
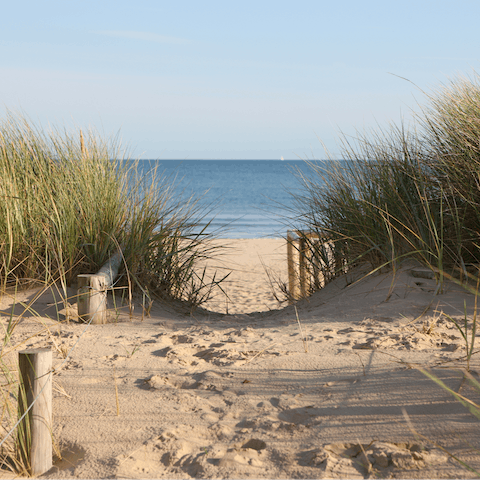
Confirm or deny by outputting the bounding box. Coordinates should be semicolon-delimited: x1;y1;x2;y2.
77;274;107;325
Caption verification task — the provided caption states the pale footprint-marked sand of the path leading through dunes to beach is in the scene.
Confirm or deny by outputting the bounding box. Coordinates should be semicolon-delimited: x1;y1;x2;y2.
0;240;480;480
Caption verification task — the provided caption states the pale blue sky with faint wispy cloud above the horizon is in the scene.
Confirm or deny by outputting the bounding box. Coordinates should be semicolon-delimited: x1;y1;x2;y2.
0;0;480;159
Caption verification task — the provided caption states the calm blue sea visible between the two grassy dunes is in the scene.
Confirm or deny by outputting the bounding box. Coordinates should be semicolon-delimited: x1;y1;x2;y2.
136;160;322;238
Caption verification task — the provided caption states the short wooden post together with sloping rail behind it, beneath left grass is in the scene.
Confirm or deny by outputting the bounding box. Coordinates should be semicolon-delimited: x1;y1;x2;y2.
77;252;123;325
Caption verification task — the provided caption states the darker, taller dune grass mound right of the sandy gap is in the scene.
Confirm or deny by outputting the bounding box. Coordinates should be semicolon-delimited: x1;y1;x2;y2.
294;76;480;291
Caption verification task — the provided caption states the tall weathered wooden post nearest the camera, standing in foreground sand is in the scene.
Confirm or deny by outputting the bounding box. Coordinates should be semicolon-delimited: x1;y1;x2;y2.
17;348;52;476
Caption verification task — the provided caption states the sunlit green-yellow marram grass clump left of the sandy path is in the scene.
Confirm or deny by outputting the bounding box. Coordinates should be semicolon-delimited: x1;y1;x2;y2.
0;113;226;302
